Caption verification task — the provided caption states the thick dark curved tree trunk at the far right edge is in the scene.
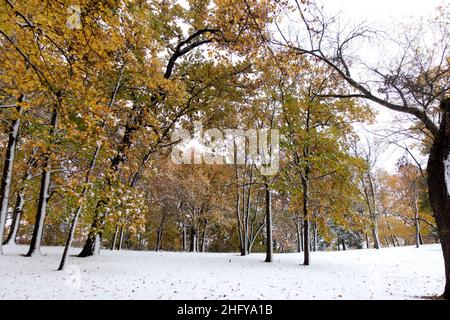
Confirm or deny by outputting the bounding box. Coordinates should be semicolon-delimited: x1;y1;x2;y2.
427;99;450;299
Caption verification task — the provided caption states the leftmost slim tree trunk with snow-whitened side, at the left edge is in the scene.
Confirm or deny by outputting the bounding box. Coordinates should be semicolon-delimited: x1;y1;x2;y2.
0;104;23;254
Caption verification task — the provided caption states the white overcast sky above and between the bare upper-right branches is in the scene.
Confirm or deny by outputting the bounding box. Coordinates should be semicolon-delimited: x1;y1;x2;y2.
317;0;450;172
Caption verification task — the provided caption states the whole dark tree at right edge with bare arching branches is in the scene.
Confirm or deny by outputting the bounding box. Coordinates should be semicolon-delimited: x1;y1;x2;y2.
274;1;450;298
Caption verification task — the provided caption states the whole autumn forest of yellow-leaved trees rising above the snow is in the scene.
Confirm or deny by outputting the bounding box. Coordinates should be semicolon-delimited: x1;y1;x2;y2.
0;0;450;298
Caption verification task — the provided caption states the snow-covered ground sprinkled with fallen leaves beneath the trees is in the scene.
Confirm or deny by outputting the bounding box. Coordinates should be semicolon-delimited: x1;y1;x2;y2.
0;245;444;299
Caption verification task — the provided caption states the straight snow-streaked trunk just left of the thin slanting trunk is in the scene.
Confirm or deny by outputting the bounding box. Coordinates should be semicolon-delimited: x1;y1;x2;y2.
26;106;58;257
